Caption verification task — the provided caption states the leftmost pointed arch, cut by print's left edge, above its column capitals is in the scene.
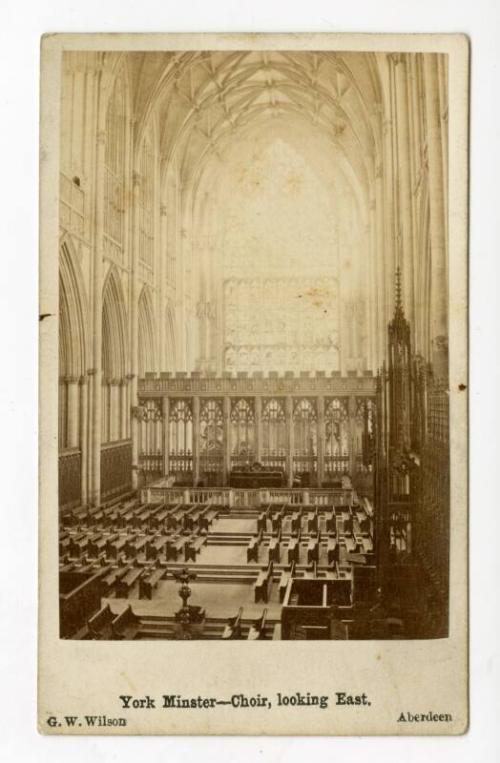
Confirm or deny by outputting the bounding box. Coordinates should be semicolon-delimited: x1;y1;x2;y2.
59;234;88;377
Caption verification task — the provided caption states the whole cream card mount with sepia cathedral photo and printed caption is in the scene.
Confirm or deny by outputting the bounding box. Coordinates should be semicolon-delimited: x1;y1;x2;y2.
38;34;468;735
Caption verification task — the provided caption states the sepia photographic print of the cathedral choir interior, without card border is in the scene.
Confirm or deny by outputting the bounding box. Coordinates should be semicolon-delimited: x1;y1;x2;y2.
58;50;450;640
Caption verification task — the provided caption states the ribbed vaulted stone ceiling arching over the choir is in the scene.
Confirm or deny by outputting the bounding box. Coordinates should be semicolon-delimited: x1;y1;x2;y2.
120;51;382;204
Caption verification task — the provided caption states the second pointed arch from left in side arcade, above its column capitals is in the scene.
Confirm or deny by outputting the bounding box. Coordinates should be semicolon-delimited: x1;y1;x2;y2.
102;267;128;379
